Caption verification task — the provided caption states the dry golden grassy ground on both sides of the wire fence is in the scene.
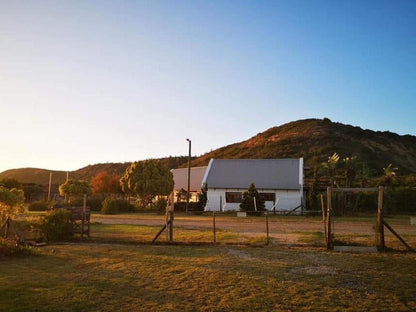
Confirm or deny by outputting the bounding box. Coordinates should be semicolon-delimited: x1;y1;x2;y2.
0;215;416;311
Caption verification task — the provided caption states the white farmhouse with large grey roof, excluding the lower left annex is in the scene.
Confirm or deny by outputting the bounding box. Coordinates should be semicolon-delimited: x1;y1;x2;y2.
202;158;304;211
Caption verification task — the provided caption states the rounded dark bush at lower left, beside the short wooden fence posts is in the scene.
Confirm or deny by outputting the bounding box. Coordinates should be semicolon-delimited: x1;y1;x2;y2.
39;209;74;241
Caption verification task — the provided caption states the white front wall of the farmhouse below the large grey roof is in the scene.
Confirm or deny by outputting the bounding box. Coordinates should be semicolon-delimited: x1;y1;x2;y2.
204;188;302;211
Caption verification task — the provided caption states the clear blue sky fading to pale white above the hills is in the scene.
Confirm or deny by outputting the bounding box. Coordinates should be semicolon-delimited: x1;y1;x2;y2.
0;0;416;172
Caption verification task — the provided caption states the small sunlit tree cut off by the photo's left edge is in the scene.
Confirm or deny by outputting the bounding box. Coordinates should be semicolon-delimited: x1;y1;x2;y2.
0;186;25;225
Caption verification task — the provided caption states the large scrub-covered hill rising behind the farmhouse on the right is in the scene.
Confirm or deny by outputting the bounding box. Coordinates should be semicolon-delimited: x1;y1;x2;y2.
192;118;416;175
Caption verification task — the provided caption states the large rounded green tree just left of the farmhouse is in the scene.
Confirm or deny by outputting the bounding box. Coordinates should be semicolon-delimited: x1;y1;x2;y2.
120;160;174;206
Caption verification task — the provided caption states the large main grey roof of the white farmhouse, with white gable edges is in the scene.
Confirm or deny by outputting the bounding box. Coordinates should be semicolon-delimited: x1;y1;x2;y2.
202;159;303;190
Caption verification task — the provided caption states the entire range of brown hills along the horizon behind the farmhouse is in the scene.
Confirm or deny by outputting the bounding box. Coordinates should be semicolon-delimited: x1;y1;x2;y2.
0;118;416;185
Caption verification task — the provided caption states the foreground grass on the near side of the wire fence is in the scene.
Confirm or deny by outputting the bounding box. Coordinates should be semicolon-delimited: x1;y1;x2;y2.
0;245;416;312
